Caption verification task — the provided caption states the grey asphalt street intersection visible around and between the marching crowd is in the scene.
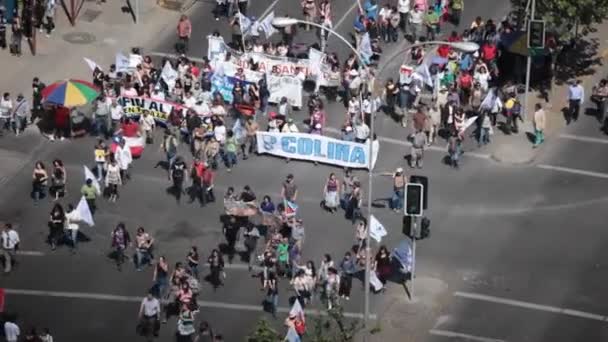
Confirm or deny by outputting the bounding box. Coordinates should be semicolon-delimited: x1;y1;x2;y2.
0;0;608;342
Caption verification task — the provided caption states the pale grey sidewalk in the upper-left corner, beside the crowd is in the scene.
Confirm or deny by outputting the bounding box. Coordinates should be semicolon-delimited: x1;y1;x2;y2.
0;1;180;180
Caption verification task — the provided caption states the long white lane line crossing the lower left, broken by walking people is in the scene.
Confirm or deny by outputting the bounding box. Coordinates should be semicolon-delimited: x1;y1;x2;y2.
4;289;376;320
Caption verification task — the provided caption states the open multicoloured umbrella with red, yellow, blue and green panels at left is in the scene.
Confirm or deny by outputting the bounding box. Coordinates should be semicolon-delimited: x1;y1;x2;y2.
42;80;99;107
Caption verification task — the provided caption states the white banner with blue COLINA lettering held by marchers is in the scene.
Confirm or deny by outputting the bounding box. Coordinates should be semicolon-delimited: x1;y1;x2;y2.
257;132;375;169
